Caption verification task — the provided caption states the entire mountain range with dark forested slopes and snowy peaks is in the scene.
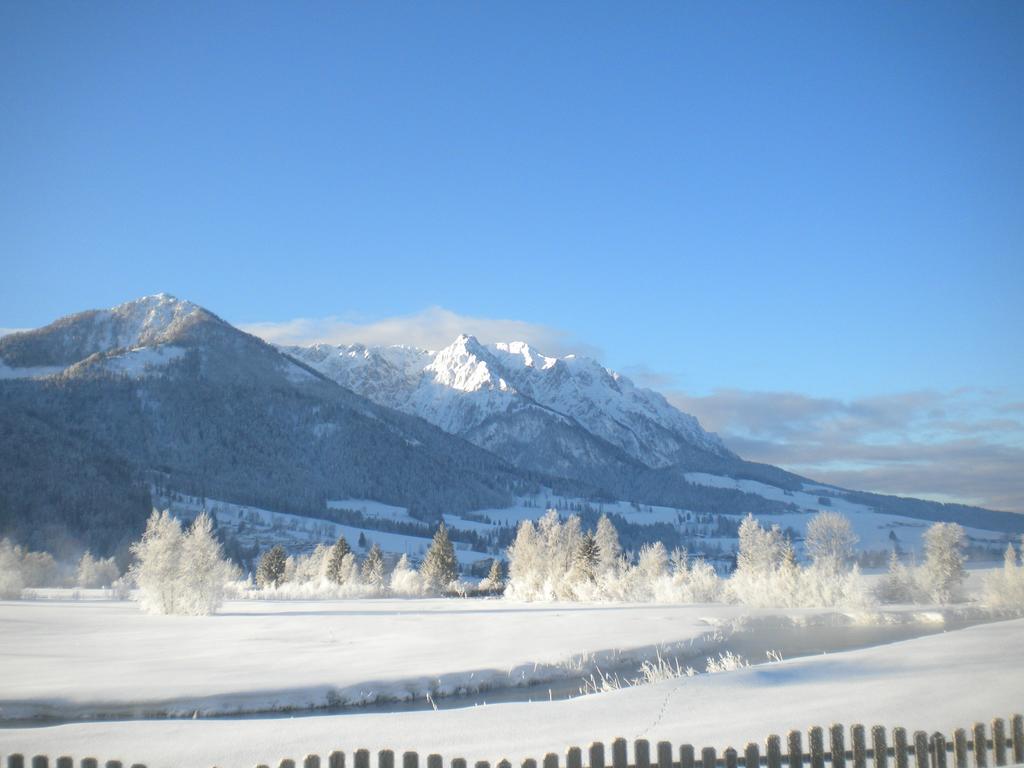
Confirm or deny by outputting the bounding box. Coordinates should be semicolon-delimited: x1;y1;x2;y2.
0;294;1024;552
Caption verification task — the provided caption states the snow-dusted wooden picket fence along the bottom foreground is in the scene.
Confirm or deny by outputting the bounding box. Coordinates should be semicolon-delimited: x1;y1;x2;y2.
6;715;1024;768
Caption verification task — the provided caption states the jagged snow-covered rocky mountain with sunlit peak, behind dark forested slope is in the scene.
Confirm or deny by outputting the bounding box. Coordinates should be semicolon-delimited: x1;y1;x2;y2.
285;334;733;468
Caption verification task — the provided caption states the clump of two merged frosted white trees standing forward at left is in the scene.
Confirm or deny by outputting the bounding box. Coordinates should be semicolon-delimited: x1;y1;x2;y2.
131;510;233;615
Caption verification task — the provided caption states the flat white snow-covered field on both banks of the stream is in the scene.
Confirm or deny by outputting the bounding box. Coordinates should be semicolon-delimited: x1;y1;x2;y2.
0;600;1024;768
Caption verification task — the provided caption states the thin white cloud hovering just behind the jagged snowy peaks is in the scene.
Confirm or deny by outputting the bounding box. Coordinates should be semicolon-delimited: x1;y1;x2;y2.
239;306;601;356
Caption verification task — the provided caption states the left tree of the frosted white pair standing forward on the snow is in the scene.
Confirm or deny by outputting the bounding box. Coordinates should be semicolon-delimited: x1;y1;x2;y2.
131;510;184;613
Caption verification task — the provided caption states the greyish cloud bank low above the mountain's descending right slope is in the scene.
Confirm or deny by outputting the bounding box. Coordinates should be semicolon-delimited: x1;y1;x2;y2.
668;389;1024;512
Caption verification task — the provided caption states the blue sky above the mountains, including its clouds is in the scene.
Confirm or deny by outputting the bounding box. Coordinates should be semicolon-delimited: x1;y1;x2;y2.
0;2;1024;511
